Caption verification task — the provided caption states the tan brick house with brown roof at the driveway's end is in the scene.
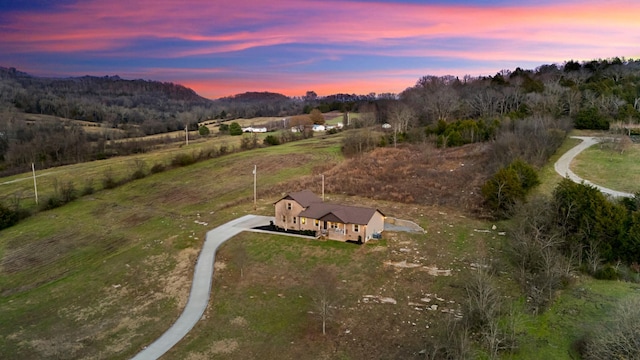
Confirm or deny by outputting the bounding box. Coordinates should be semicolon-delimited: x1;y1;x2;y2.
274;190;385;243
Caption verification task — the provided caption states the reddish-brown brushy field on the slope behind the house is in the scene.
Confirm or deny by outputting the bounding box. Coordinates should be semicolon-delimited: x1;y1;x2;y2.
277;143;491;216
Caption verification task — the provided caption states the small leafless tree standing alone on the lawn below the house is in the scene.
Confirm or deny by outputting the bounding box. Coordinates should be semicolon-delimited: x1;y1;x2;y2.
311;267;338;335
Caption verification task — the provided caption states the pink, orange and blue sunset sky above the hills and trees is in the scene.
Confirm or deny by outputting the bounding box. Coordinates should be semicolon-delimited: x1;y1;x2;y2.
0;0;640;99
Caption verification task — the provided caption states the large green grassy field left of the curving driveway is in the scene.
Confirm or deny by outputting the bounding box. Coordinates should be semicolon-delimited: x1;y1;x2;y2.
0;133;339;358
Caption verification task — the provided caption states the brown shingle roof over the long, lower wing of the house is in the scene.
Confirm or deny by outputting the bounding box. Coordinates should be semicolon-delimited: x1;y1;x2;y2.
299;203;384;225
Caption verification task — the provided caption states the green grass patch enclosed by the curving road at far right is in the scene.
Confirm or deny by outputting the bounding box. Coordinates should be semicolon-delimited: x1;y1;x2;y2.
571;144;640;193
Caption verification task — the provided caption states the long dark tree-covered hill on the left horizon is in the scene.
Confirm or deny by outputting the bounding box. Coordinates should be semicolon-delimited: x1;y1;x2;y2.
0;67;213;127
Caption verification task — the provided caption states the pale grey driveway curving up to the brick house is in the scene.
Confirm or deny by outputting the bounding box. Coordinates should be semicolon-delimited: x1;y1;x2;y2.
133;215;273;360
